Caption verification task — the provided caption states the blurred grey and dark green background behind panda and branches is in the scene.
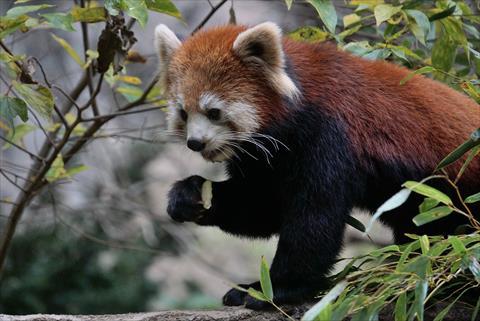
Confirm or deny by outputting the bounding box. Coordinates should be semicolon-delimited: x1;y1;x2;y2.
0;0;390;314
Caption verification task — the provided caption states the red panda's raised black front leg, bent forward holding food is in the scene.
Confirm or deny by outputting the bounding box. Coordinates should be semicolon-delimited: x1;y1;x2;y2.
167;176;280;237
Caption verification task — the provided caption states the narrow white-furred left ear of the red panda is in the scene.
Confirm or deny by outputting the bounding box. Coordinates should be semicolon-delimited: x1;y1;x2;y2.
155;24;182;85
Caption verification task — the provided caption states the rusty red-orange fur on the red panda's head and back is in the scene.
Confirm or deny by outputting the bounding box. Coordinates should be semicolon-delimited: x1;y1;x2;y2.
168;26;480;181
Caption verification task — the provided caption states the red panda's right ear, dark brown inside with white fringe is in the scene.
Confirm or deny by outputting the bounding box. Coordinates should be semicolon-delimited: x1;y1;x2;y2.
232;22;299;99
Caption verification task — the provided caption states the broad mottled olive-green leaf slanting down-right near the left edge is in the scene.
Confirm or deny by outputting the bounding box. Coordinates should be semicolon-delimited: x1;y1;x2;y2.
12;81;54;117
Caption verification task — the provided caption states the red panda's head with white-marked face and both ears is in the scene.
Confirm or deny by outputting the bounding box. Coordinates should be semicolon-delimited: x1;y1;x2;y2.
155;22;298;161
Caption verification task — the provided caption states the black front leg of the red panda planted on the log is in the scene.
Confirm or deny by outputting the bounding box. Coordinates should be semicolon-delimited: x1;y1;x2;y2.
223;203;350;310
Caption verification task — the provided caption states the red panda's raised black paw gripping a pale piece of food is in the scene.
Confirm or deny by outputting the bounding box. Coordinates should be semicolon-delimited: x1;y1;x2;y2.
167;175;207;222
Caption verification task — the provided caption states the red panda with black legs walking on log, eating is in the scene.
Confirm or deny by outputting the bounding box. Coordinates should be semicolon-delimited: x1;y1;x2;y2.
155;22;480;309
